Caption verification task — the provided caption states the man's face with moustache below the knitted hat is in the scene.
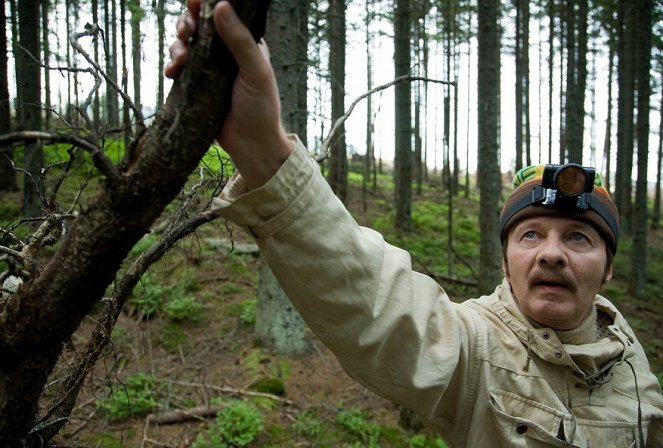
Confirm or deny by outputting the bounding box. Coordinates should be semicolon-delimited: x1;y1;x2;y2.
502;217;612;330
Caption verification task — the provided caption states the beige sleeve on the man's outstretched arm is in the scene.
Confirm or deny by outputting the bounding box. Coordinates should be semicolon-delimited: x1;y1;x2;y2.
214;136;486;432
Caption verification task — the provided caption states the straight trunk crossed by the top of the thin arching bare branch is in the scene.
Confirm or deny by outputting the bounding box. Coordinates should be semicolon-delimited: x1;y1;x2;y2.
394;0;413;231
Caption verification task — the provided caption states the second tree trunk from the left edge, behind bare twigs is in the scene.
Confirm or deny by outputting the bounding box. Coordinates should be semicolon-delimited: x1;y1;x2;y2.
16;0;44;216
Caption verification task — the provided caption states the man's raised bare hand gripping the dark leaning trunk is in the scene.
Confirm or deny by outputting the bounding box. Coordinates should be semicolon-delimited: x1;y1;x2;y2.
164;0;292;189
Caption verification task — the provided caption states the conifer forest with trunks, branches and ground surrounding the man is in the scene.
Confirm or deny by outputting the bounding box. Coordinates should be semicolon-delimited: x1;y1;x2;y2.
0;0;663;447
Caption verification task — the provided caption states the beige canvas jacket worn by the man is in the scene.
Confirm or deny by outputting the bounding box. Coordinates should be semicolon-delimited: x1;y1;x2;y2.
214;137;663;448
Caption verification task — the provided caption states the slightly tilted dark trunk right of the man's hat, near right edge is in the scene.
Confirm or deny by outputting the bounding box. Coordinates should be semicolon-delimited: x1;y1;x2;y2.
629;0;653;299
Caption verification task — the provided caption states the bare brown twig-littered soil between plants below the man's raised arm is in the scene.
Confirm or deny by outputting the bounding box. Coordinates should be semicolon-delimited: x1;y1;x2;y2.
53;186;416;448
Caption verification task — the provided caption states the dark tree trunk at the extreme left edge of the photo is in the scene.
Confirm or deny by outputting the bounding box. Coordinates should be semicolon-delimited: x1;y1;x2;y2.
0;2;18;192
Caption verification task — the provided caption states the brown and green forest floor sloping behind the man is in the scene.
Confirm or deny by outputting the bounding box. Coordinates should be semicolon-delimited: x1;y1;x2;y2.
45;179;663;448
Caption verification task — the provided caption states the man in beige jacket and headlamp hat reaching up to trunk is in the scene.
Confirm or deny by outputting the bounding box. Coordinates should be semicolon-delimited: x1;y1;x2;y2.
166;0;663;448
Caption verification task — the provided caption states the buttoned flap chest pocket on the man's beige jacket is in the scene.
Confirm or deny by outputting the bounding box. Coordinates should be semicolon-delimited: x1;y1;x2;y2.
489;388;587;448
